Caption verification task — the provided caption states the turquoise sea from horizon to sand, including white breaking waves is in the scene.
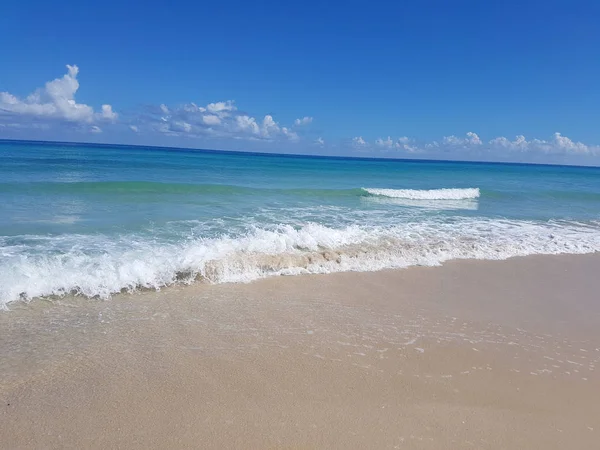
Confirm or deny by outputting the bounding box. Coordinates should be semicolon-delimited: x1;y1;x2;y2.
0;142;600;304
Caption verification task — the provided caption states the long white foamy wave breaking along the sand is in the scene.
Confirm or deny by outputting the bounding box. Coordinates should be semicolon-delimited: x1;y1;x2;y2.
0;218;600;306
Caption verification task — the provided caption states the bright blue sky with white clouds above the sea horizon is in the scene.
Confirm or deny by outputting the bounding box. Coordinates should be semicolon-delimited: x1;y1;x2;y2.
0;0;600;164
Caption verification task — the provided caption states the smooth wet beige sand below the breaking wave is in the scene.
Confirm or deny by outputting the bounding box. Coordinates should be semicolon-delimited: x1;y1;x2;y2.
0;255;600;449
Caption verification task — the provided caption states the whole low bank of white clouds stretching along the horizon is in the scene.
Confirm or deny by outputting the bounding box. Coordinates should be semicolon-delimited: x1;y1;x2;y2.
0;65;600;164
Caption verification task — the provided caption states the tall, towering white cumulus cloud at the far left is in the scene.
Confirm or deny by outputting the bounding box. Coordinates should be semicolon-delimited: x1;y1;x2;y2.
0;65;118;126
